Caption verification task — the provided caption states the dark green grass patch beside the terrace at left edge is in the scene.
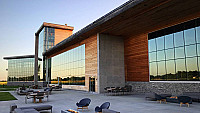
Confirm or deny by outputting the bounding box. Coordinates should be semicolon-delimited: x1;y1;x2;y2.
0;92;17;101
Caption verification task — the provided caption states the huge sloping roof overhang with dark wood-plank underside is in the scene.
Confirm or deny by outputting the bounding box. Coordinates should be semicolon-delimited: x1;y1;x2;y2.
43;0;200;57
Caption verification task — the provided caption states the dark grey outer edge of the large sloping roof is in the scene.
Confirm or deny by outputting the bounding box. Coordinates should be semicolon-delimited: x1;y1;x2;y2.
41;0;144;56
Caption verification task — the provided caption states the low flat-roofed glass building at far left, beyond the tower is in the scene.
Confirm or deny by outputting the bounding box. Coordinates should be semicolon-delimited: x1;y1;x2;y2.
3;55;42;85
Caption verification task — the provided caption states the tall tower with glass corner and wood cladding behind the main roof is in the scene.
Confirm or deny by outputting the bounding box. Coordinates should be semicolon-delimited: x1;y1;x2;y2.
34;22;74;85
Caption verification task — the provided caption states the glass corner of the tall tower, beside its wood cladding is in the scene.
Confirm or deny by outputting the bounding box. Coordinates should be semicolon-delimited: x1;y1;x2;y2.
38;27;55;81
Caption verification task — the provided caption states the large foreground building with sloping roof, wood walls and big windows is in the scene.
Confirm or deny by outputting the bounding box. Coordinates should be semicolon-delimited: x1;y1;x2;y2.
40;0;200;94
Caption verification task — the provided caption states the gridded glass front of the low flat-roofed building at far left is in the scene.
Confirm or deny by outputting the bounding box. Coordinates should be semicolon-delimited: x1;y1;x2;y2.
8;58;40;82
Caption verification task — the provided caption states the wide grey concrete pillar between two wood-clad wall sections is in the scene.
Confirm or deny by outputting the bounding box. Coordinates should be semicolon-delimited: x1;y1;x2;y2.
97;34;125;93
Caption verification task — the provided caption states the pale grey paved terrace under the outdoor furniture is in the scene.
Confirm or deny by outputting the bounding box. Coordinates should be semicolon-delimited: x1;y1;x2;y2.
0;90;200;113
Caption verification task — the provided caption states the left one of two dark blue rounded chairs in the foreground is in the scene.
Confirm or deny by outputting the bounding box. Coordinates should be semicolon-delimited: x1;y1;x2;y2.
76;98;91;111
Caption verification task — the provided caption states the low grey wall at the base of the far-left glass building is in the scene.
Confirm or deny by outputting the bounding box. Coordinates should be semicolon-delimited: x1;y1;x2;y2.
7;82;43;86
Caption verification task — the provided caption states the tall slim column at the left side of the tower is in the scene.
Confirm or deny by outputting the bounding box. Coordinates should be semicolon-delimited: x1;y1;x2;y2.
34;34;39;85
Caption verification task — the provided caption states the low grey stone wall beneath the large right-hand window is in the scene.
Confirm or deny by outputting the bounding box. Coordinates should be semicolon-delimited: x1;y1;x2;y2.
126;82;200;95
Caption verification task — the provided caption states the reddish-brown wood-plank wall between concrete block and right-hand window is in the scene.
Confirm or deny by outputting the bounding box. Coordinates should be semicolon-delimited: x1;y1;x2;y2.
124;34;149;81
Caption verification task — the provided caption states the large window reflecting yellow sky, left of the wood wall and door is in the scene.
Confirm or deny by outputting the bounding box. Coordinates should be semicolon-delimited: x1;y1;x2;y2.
51;44;85;85
